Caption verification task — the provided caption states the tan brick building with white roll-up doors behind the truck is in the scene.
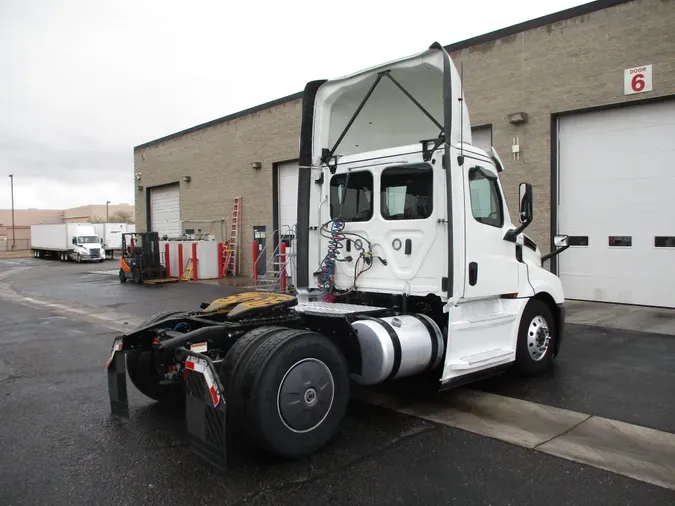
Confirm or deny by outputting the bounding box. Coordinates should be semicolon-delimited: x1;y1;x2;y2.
134;0;675;306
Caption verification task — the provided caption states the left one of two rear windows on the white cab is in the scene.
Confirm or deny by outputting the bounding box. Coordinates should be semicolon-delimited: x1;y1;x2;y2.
330;171;373;222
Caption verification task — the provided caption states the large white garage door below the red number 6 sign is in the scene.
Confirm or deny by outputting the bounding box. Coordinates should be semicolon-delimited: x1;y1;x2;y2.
558;101;675;307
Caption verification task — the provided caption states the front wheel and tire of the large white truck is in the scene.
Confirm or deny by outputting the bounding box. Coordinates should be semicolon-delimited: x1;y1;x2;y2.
514;299;558;376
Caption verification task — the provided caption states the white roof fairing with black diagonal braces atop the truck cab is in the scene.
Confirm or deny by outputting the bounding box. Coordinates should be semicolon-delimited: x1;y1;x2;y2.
312;43;471;166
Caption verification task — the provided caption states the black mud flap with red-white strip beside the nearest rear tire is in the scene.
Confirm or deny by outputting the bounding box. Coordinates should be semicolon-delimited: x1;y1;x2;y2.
179;348;234;470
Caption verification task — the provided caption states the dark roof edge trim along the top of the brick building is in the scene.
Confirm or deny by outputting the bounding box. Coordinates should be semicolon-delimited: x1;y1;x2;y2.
134;0;634;151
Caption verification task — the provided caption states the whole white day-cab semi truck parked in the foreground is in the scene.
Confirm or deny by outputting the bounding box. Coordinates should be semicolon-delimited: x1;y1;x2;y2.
106;43;567;466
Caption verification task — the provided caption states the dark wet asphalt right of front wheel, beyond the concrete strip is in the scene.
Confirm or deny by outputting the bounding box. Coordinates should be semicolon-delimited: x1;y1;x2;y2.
472;324;675;432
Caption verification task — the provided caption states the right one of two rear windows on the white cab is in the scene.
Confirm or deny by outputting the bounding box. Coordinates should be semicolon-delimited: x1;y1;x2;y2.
380;166;434;220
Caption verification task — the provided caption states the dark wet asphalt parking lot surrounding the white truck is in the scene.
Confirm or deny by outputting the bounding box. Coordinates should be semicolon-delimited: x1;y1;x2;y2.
0;258;675;505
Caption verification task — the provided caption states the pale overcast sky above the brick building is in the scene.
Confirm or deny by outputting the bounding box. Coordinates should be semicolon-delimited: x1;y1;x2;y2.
0;0;586;208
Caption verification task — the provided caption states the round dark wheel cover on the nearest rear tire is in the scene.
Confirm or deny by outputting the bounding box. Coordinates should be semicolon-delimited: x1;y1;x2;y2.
277;358;335;433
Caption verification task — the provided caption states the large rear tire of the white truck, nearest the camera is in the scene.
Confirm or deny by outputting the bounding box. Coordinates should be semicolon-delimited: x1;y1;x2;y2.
240;329;350;459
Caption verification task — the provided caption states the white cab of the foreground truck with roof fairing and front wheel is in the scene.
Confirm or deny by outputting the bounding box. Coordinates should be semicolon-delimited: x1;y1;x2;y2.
297;44;566;386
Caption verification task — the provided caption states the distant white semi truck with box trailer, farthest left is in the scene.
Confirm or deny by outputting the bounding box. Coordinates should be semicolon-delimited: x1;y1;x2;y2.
30;223;105;262
